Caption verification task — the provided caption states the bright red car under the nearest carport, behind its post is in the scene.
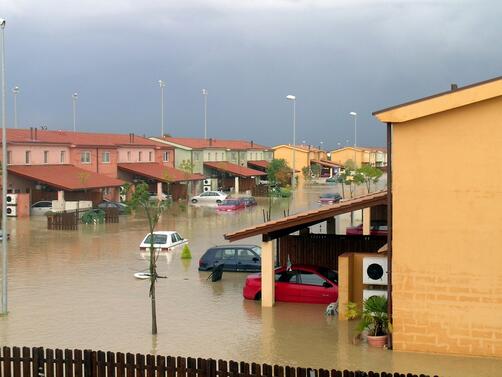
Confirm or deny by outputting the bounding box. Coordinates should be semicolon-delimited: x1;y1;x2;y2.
242;264;338;304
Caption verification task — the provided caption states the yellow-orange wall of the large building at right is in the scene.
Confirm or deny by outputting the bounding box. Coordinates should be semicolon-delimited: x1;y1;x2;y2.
392;97;502;357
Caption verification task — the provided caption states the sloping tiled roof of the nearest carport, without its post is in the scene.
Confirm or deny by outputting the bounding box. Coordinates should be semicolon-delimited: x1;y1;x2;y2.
224;190;387;241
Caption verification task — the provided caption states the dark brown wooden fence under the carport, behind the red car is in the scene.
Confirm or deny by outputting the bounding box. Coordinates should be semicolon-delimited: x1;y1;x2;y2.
278;234;387;270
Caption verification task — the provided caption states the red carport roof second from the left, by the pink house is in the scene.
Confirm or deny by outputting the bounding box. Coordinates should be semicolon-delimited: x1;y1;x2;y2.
118;162;204;183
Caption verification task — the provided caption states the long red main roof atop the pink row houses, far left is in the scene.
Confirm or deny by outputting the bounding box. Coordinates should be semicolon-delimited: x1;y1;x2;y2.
0;128;172;149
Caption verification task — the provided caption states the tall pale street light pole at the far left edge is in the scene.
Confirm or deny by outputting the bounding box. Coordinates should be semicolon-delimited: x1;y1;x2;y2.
0;18;8;315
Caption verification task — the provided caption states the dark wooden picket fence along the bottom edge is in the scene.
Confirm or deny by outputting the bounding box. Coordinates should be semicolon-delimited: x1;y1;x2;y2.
0;347;436;377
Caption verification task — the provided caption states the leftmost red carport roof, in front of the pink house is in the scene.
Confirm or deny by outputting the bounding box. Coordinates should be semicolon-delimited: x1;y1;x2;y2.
8;165;124;191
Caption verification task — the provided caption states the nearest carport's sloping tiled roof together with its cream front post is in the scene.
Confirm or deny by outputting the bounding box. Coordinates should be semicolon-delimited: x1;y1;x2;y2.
224;190;387;307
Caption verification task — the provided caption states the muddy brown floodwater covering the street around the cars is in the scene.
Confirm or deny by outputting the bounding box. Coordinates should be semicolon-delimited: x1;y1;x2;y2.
0;181;502;376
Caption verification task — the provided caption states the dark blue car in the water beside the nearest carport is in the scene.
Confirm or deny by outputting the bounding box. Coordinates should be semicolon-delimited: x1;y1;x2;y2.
199;245;261;272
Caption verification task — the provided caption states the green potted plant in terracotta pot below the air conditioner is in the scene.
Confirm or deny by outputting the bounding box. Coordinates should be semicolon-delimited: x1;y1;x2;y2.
358;296;391;347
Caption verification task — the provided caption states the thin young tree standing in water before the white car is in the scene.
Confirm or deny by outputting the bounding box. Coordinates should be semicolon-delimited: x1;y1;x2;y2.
129;182;169;335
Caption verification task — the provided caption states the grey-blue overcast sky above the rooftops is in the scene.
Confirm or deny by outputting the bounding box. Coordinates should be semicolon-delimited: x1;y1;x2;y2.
0;0;502;148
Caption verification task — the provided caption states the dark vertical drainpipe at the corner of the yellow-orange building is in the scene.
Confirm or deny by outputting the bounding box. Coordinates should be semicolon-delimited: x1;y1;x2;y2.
387;122;393;349
